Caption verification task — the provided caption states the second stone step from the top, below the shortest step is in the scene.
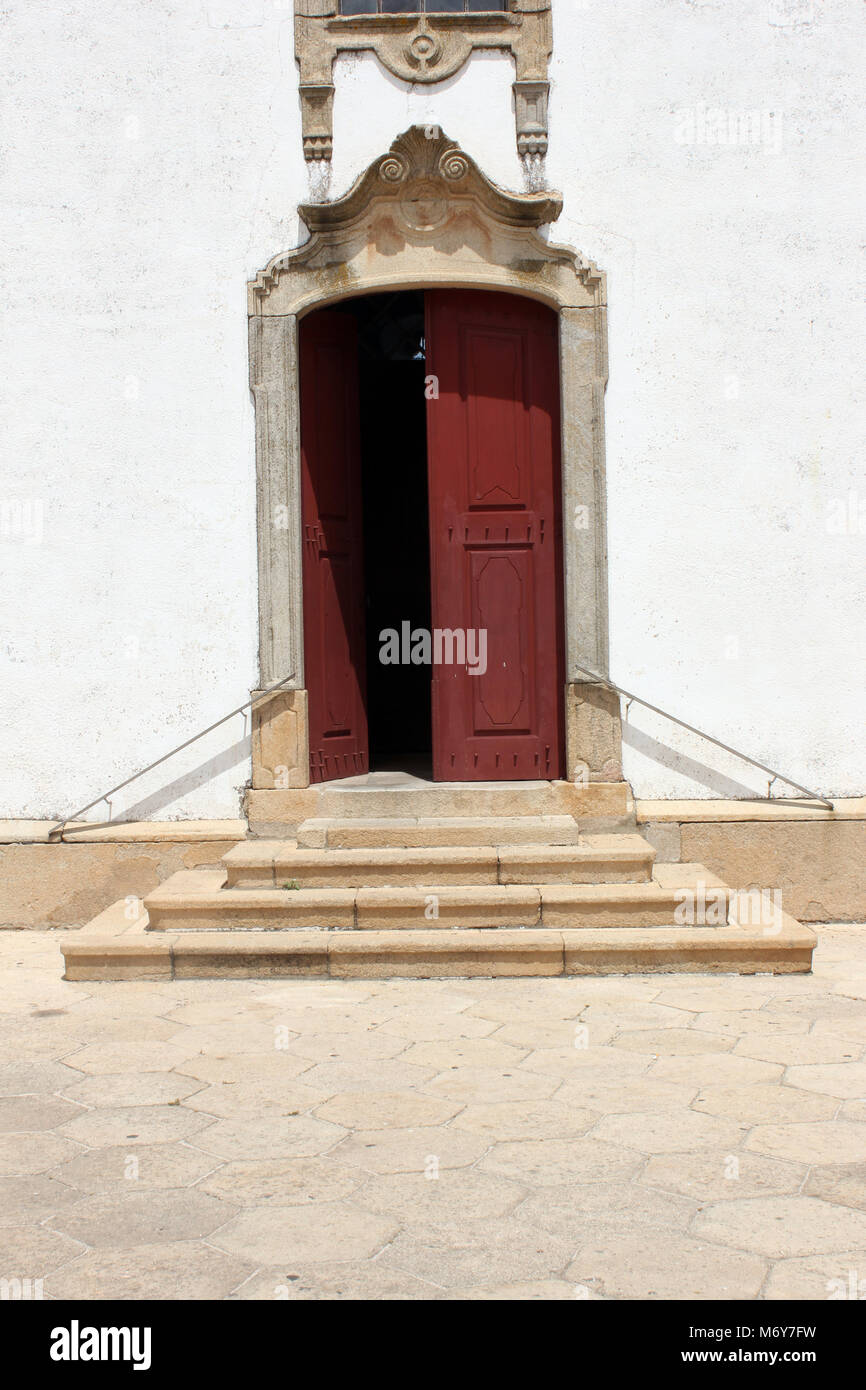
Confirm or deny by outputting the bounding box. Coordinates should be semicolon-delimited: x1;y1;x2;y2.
222;835;655;890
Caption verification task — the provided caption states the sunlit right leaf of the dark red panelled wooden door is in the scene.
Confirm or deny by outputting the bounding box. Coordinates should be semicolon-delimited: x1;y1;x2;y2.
427;291;564;781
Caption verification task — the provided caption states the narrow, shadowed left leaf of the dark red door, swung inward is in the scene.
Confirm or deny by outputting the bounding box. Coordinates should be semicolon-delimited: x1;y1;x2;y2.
300;309;368;783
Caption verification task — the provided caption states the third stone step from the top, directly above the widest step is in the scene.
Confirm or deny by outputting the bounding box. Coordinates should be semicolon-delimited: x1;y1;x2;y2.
145;865;728;931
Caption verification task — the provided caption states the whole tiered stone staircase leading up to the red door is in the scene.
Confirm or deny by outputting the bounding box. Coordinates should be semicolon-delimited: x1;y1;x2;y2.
64;784;815;980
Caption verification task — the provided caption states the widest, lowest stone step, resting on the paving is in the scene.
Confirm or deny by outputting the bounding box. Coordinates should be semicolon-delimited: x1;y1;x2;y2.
61;917;816;980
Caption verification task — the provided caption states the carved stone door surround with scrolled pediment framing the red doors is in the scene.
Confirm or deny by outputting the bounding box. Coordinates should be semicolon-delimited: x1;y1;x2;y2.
249;126;621;790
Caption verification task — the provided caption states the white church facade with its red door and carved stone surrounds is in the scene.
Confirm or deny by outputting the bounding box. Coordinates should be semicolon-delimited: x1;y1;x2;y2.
0;0;866;934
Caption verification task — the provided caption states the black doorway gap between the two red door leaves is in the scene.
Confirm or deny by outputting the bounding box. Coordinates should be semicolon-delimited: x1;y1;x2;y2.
345;292;432;777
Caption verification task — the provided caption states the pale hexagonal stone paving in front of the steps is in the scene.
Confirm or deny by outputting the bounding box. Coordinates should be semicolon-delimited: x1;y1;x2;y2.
0;926;866;1300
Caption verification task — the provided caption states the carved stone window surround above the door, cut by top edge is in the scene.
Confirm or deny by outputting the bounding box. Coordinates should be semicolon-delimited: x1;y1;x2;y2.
295;0;553;161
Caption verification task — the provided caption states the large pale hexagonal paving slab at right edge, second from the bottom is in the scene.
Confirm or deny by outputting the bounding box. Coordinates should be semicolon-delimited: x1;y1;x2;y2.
694;1197;866;1259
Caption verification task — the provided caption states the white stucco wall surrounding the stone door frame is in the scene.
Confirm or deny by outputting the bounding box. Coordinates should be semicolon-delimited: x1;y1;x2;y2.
0;0;866;817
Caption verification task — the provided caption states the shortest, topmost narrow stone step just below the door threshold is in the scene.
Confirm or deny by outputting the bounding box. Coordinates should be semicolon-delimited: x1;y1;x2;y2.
297;816;578;849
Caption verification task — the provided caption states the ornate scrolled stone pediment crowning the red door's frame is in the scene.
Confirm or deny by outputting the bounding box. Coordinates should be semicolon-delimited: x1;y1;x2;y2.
249;125;605;316
